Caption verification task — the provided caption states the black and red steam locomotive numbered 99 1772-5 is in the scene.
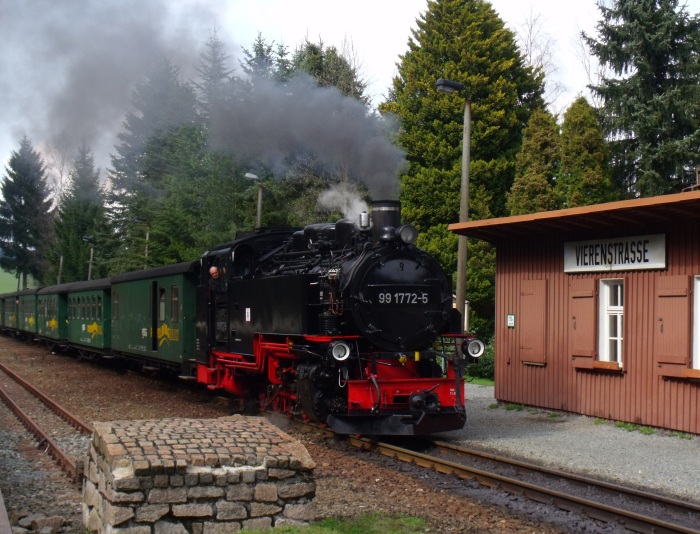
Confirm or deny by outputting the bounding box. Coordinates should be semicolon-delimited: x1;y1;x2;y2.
196;201;483;435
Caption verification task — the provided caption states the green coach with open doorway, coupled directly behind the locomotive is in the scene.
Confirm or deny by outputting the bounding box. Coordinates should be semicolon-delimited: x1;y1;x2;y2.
112;260;199;376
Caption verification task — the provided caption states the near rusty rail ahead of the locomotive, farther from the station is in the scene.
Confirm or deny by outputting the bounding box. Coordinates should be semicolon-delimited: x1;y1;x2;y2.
348;436;700;534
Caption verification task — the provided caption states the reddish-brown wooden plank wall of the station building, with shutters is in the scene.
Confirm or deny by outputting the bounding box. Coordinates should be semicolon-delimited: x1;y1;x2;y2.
492;222;700;434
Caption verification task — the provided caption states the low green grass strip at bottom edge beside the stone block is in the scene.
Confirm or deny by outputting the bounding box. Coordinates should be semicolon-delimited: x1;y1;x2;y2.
242;514;426;534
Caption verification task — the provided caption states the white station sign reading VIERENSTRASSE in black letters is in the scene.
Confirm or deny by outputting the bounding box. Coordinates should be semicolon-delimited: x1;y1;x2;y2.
564;234;666;273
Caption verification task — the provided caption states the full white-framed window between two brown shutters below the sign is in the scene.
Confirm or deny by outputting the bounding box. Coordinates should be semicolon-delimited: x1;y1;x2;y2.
598;278;625;366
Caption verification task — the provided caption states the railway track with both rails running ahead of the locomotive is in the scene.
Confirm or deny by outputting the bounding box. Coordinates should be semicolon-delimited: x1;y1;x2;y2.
348;437;700;534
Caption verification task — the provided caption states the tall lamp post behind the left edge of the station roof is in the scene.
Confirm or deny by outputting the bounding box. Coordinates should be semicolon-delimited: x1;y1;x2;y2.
436;78;472;336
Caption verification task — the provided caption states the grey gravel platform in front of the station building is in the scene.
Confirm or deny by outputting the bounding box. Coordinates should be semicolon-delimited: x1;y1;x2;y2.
444;384;700;503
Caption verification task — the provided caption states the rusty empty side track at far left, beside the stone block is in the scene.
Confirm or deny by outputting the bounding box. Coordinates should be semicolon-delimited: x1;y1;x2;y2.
0;364;92;483
